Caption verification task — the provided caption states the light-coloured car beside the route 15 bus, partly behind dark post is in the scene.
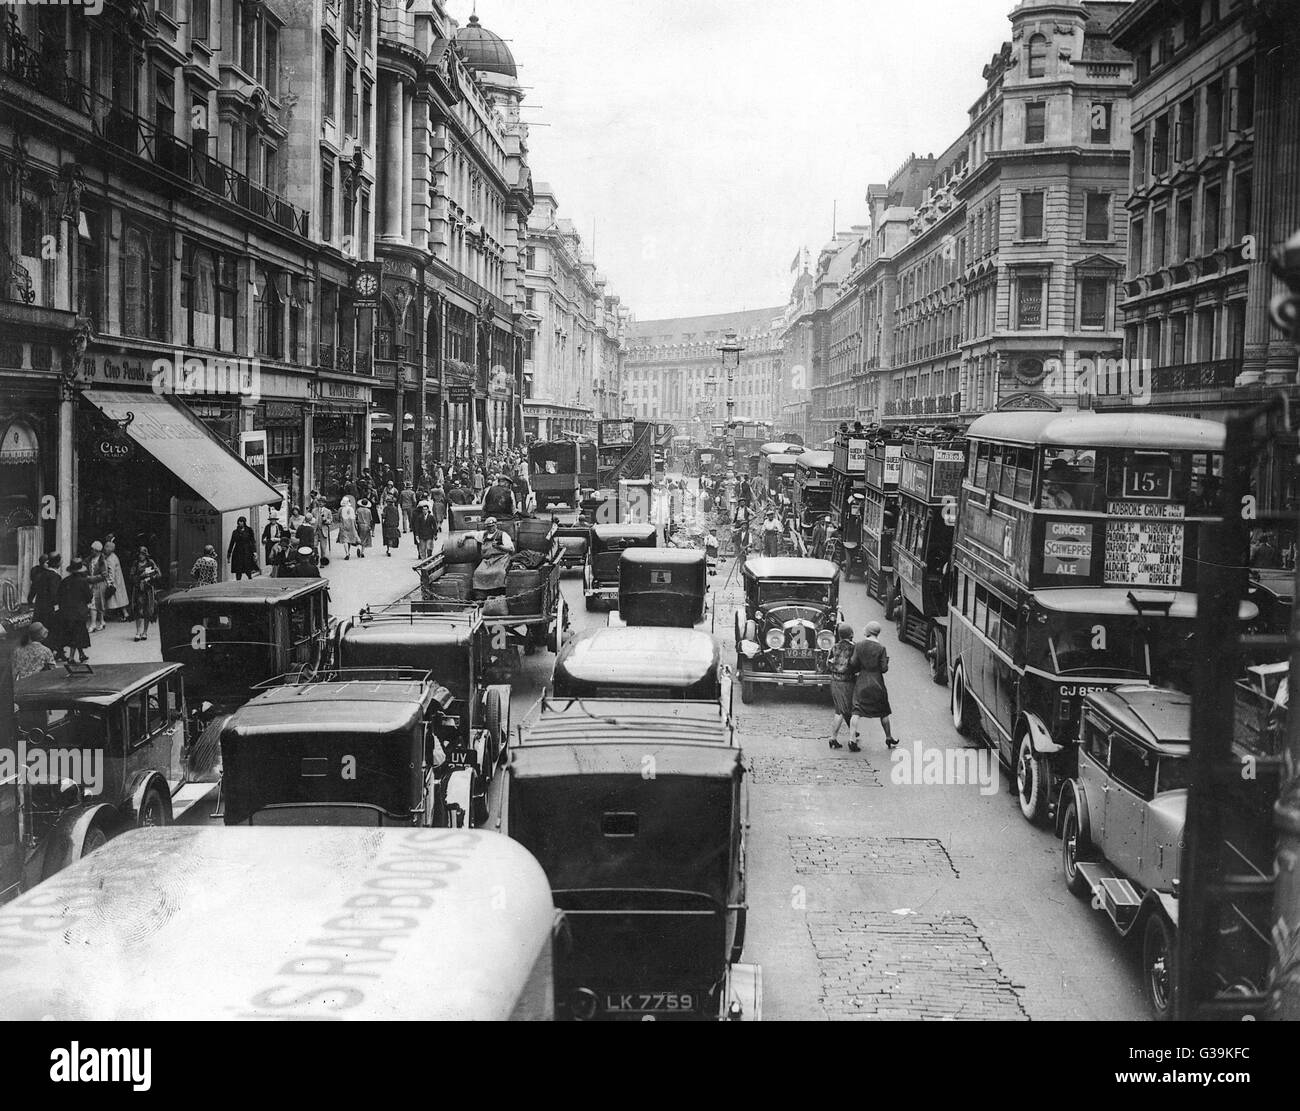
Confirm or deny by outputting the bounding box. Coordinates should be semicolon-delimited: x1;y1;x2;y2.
1057;686;1192;1019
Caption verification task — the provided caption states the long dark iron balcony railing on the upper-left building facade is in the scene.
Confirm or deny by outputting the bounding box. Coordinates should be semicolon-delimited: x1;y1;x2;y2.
0;21;309;238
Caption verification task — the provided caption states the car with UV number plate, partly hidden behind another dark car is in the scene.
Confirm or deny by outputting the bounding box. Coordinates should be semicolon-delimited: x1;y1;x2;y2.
334;602;510;821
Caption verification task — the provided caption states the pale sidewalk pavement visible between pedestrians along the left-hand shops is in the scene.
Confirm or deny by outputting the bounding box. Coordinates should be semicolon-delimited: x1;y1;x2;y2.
86;533;441;667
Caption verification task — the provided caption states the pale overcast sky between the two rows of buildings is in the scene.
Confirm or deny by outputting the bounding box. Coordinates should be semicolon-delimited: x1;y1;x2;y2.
446;0;1034;320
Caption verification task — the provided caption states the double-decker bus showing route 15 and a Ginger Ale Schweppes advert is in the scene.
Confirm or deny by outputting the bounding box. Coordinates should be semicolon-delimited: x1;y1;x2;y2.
946;411;1258;823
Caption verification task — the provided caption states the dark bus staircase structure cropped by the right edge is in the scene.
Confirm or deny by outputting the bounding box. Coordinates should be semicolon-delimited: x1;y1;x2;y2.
1185;395;1300;1020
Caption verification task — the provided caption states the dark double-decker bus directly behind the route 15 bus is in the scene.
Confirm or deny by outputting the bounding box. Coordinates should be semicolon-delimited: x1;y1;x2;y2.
891;430;966;686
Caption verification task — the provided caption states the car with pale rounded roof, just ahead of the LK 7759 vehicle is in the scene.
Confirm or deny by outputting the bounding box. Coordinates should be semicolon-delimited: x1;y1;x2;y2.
551;626;729;715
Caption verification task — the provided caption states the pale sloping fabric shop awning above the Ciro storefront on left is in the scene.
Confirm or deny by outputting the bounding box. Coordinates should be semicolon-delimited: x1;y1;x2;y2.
83;390;281;513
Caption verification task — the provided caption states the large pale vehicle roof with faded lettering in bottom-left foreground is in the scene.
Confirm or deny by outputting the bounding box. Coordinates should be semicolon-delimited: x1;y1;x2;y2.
0;826;558;1024
